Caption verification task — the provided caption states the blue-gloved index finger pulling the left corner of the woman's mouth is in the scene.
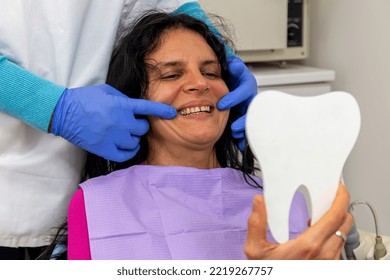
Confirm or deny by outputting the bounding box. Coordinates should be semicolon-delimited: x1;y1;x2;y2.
129;99;177;119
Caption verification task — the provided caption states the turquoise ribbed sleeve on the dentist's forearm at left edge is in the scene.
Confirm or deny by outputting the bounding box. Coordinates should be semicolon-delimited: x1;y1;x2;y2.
0;55;65;132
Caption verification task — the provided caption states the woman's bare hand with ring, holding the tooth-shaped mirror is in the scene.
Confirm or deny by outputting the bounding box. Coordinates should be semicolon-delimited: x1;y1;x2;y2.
244;183;353;260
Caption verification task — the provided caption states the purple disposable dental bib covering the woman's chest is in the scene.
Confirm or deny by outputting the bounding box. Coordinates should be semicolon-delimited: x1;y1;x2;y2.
81;165;309;260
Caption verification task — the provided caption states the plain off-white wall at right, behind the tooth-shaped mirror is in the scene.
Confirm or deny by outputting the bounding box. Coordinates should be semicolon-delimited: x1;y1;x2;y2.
305;0;390;235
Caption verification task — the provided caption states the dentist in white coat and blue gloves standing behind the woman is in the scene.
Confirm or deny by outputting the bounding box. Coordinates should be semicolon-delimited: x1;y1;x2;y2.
0;0;257;259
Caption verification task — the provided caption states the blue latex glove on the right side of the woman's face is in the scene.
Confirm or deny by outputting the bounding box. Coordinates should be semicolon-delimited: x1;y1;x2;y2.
217;56;257;151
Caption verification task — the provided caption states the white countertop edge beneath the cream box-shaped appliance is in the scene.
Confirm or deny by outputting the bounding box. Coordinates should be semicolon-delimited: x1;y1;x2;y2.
248;64;336;86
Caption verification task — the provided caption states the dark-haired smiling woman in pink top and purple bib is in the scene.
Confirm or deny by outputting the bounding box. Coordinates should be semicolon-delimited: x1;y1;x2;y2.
68;10;348;259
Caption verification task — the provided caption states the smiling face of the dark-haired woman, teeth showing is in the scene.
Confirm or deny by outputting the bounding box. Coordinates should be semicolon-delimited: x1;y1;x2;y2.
146;29;229;149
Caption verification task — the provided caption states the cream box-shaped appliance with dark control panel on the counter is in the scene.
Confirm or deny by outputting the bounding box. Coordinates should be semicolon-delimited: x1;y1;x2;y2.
199;0;310;62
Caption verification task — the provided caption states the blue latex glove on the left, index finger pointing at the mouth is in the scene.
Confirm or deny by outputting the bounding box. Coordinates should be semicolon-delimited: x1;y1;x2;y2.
51;84;176;162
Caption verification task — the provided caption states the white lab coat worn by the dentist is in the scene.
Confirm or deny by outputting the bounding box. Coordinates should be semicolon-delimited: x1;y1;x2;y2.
0;0;195;247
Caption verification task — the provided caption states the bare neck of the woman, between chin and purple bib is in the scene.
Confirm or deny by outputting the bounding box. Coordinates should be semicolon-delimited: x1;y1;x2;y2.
145;140;221;169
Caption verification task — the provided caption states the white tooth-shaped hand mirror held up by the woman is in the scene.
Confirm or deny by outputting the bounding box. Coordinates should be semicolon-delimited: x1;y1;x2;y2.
246;91;360;243
